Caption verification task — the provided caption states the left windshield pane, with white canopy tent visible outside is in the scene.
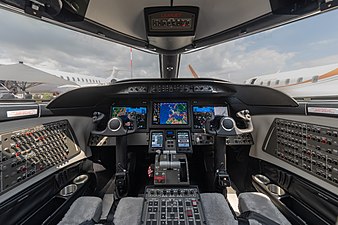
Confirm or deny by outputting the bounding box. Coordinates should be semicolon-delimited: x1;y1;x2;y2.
0;9;160;100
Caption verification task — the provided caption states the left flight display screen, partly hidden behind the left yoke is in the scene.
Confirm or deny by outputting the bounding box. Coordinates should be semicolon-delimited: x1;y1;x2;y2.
111;106;147;130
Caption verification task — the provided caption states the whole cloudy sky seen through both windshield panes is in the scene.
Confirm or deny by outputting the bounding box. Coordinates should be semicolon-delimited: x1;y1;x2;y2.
0;9;338;83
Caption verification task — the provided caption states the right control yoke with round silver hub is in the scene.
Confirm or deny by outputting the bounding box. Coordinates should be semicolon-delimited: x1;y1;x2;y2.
205;110;253;137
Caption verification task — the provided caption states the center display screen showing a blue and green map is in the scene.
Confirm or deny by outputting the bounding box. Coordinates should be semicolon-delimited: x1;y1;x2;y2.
152;102;188;125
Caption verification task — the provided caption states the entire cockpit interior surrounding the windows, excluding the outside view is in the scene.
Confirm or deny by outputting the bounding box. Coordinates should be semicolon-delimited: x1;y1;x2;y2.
0;0;338;225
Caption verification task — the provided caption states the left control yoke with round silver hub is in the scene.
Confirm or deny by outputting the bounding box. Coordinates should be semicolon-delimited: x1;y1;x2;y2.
92;117;137;137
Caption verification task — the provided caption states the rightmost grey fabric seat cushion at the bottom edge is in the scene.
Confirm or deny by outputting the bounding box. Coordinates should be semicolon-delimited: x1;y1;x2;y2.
238;192;291;225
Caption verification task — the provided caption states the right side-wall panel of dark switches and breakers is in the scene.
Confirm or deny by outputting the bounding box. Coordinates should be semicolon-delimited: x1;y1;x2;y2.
264;119;338;186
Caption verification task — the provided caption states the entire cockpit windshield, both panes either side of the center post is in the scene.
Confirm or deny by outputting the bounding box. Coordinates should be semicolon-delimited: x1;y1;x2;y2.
0;9;338;100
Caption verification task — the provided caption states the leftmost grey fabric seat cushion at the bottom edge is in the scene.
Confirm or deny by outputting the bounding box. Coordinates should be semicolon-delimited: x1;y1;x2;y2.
59;196;102;225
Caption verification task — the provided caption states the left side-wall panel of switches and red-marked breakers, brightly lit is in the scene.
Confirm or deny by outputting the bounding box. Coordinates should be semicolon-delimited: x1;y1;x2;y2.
0;120;80;193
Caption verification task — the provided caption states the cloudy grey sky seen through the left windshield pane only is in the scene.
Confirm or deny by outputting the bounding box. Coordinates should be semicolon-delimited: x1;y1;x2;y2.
0;10;159;77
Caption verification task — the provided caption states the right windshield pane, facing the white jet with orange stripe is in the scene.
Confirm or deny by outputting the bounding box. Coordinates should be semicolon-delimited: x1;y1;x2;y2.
180;10;338;97
